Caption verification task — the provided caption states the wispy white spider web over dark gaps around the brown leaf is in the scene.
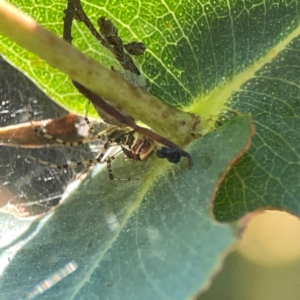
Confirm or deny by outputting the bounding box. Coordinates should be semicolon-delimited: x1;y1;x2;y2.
0;58;103;215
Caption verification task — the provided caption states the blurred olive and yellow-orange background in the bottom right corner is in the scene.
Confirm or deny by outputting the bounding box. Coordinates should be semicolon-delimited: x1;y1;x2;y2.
198;211;300;300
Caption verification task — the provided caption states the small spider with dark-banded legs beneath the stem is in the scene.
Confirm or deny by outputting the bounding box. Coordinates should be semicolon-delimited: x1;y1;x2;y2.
19;93;176;181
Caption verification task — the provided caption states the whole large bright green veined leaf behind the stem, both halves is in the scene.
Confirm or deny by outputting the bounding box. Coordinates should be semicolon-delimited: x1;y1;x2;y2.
0;1;300;298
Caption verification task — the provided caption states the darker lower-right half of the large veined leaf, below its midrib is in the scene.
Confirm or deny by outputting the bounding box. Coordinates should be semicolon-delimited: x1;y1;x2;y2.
214;37;300;222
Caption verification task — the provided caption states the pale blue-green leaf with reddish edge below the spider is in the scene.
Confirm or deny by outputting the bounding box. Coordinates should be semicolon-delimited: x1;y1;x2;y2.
0;115;252;299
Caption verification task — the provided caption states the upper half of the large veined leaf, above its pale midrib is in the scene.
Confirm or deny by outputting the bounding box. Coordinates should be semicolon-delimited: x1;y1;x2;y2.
1;1;299;114
